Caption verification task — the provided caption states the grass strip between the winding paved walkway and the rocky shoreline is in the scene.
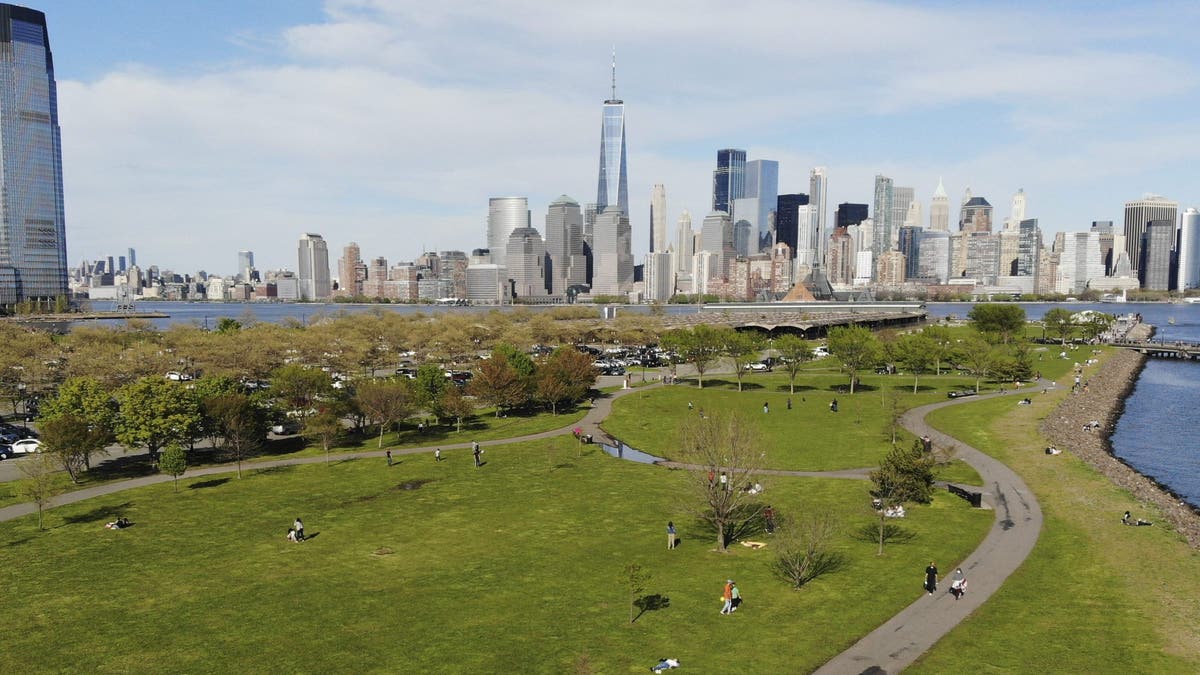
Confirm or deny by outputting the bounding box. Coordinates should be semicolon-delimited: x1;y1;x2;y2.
912;372;1200;673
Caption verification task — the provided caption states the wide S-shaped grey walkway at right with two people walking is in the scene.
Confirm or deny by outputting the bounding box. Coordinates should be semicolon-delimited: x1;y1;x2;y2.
817;387;1042;675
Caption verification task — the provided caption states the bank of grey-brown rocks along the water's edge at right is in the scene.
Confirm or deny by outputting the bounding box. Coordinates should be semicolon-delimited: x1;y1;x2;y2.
1042;325;1200;548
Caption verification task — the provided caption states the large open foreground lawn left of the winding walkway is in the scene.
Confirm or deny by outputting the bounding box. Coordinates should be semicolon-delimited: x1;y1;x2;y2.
0;437;992;673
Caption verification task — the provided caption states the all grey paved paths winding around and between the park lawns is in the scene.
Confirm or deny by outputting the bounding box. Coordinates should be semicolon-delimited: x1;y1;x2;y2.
0;374;1042;674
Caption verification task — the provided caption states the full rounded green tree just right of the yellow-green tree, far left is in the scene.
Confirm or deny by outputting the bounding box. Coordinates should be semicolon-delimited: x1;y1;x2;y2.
116;377;200;459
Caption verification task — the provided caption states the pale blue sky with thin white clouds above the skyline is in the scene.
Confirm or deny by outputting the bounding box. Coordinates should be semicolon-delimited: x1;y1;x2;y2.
31;0;1200;276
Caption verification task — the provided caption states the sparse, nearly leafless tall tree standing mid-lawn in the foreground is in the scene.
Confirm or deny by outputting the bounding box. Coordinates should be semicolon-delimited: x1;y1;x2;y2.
679;413;766;552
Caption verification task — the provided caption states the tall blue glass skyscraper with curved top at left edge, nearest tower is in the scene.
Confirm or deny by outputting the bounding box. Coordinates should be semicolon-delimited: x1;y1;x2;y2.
0;4;67;305
